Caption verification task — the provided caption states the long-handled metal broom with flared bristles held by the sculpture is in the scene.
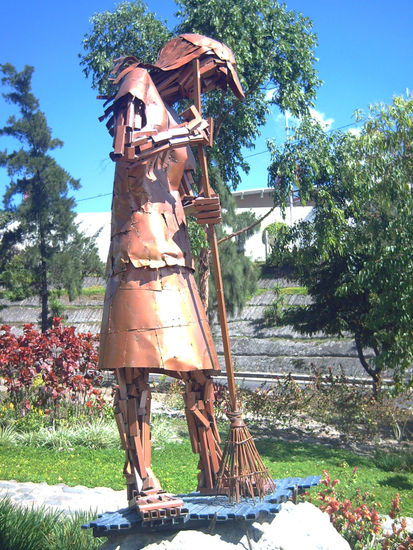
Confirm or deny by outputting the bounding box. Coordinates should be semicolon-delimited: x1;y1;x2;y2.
193;59;275;502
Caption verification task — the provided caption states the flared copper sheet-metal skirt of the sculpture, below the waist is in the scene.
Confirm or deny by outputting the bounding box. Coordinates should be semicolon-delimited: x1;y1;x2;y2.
99;264;219;371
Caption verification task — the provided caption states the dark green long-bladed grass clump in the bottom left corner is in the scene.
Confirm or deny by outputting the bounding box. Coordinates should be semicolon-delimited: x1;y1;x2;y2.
0;499;103;550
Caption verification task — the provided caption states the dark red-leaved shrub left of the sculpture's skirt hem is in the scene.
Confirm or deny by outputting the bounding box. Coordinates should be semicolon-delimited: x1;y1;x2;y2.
0;319;104;417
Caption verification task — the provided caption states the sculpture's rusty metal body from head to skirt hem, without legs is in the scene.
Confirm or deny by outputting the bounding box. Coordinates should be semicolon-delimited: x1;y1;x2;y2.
99;35;242;371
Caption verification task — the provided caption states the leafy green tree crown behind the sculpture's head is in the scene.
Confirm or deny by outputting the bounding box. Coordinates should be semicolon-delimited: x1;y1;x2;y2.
80;0;320;187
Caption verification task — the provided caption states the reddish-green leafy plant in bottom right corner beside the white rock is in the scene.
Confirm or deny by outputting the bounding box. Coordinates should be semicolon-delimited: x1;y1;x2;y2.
303;467;413;550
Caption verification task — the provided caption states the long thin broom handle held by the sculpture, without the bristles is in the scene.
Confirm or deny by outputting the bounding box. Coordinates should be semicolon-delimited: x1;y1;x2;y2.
193;59;238;412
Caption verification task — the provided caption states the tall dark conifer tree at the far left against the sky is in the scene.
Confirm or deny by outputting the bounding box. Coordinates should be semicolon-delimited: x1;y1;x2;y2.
0;63;102;332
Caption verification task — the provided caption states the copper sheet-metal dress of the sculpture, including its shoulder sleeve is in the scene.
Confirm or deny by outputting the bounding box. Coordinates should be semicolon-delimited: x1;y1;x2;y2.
99;67;219;372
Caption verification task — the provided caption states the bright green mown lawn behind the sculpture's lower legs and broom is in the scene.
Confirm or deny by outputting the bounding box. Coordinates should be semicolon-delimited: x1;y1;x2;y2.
0;432;413;516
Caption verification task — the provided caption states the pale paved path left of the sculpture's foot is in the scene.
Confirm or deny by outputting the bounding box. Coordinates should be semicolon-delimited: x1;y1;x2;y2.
0;480;127;513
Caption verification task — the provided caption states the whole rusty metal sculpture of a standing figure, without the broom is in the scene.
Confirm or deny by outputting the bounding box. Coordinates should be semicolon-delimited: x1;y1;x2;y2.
99;34;243;518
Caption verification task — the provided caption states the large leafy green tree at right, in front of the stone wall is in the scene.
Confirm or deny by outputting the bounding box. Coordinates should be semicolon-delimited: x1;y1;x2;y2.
270;96;413;396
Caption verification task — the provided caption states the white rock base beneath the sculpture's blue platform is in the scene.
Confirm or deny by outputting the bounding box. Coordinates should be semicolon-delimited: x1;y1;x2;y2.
100;502;350;550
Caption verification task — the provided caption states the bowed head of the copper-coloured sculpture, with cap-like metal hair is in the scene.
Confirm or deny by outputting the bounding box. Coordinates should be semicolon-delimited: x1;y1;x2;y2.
151;34;245;103
